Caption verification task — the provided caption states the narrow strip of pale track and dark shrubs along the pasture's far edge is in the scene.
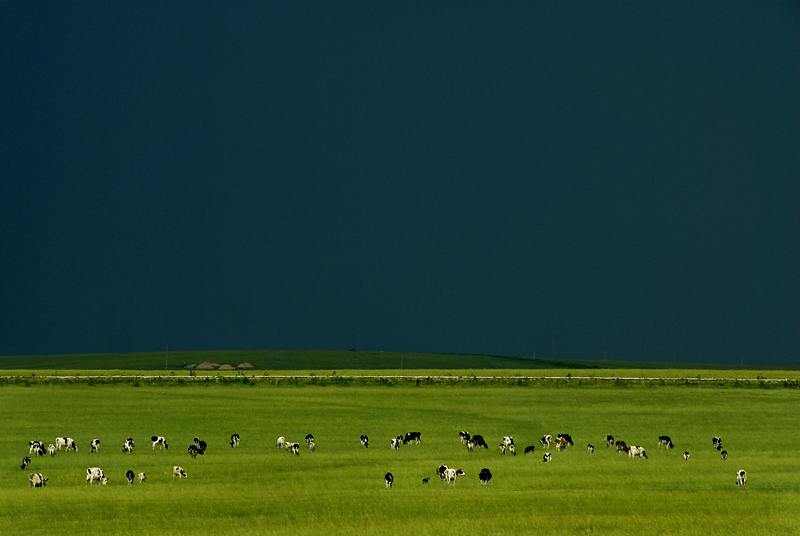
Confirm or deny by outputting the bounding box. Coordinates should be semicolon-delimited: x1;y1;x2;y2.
0;374;797;383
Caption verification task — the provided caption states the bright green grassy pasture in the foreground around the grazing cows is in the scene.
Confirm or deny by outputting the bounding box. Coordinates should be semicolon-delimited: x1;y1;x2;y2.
0;383;800;536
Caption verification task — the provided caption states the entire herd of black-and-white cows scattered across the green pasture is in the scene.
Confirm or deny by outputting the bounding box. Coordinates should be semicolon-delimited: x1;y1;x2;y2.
21;431;747;489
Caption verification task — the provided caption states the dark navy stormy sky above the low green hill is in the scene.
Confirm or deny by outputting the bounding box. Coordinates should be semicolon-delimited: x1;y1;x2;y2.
0;0;800;365
